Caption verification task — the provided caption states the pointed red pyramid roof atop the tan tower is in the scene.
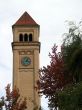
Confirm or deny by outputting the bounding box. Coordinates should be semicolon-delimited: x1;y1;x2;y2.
13;12;39;26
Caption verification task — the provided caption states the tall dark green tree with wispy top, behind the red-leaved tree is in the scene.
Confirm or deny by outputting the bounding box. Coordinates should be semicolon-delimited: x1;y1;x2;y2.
61;22;82;83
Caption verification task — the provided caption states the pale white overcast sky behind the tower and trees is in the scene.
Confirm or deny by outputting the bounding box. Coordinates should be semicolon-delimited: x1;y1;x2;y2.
0;0;82;110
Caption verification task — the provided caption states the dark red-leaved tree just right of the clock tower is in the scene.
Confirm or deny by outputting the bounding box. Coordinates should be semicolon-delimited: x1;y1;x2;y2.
37;45;72;109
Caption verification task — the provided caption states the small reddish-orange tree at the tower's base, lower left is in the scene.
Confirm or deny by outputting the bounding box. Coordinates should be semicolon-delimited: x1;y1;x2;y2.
0;84;27;110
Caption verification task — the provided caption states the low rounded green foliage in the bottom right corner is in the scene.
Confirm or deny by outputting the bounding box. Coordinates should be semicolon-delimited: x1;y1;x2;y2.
58;82;82;110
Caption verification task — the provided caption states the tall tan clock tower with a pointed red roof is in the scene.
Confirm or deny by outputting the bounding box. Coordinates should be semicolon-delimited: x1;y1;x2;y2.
12;12;40;110
